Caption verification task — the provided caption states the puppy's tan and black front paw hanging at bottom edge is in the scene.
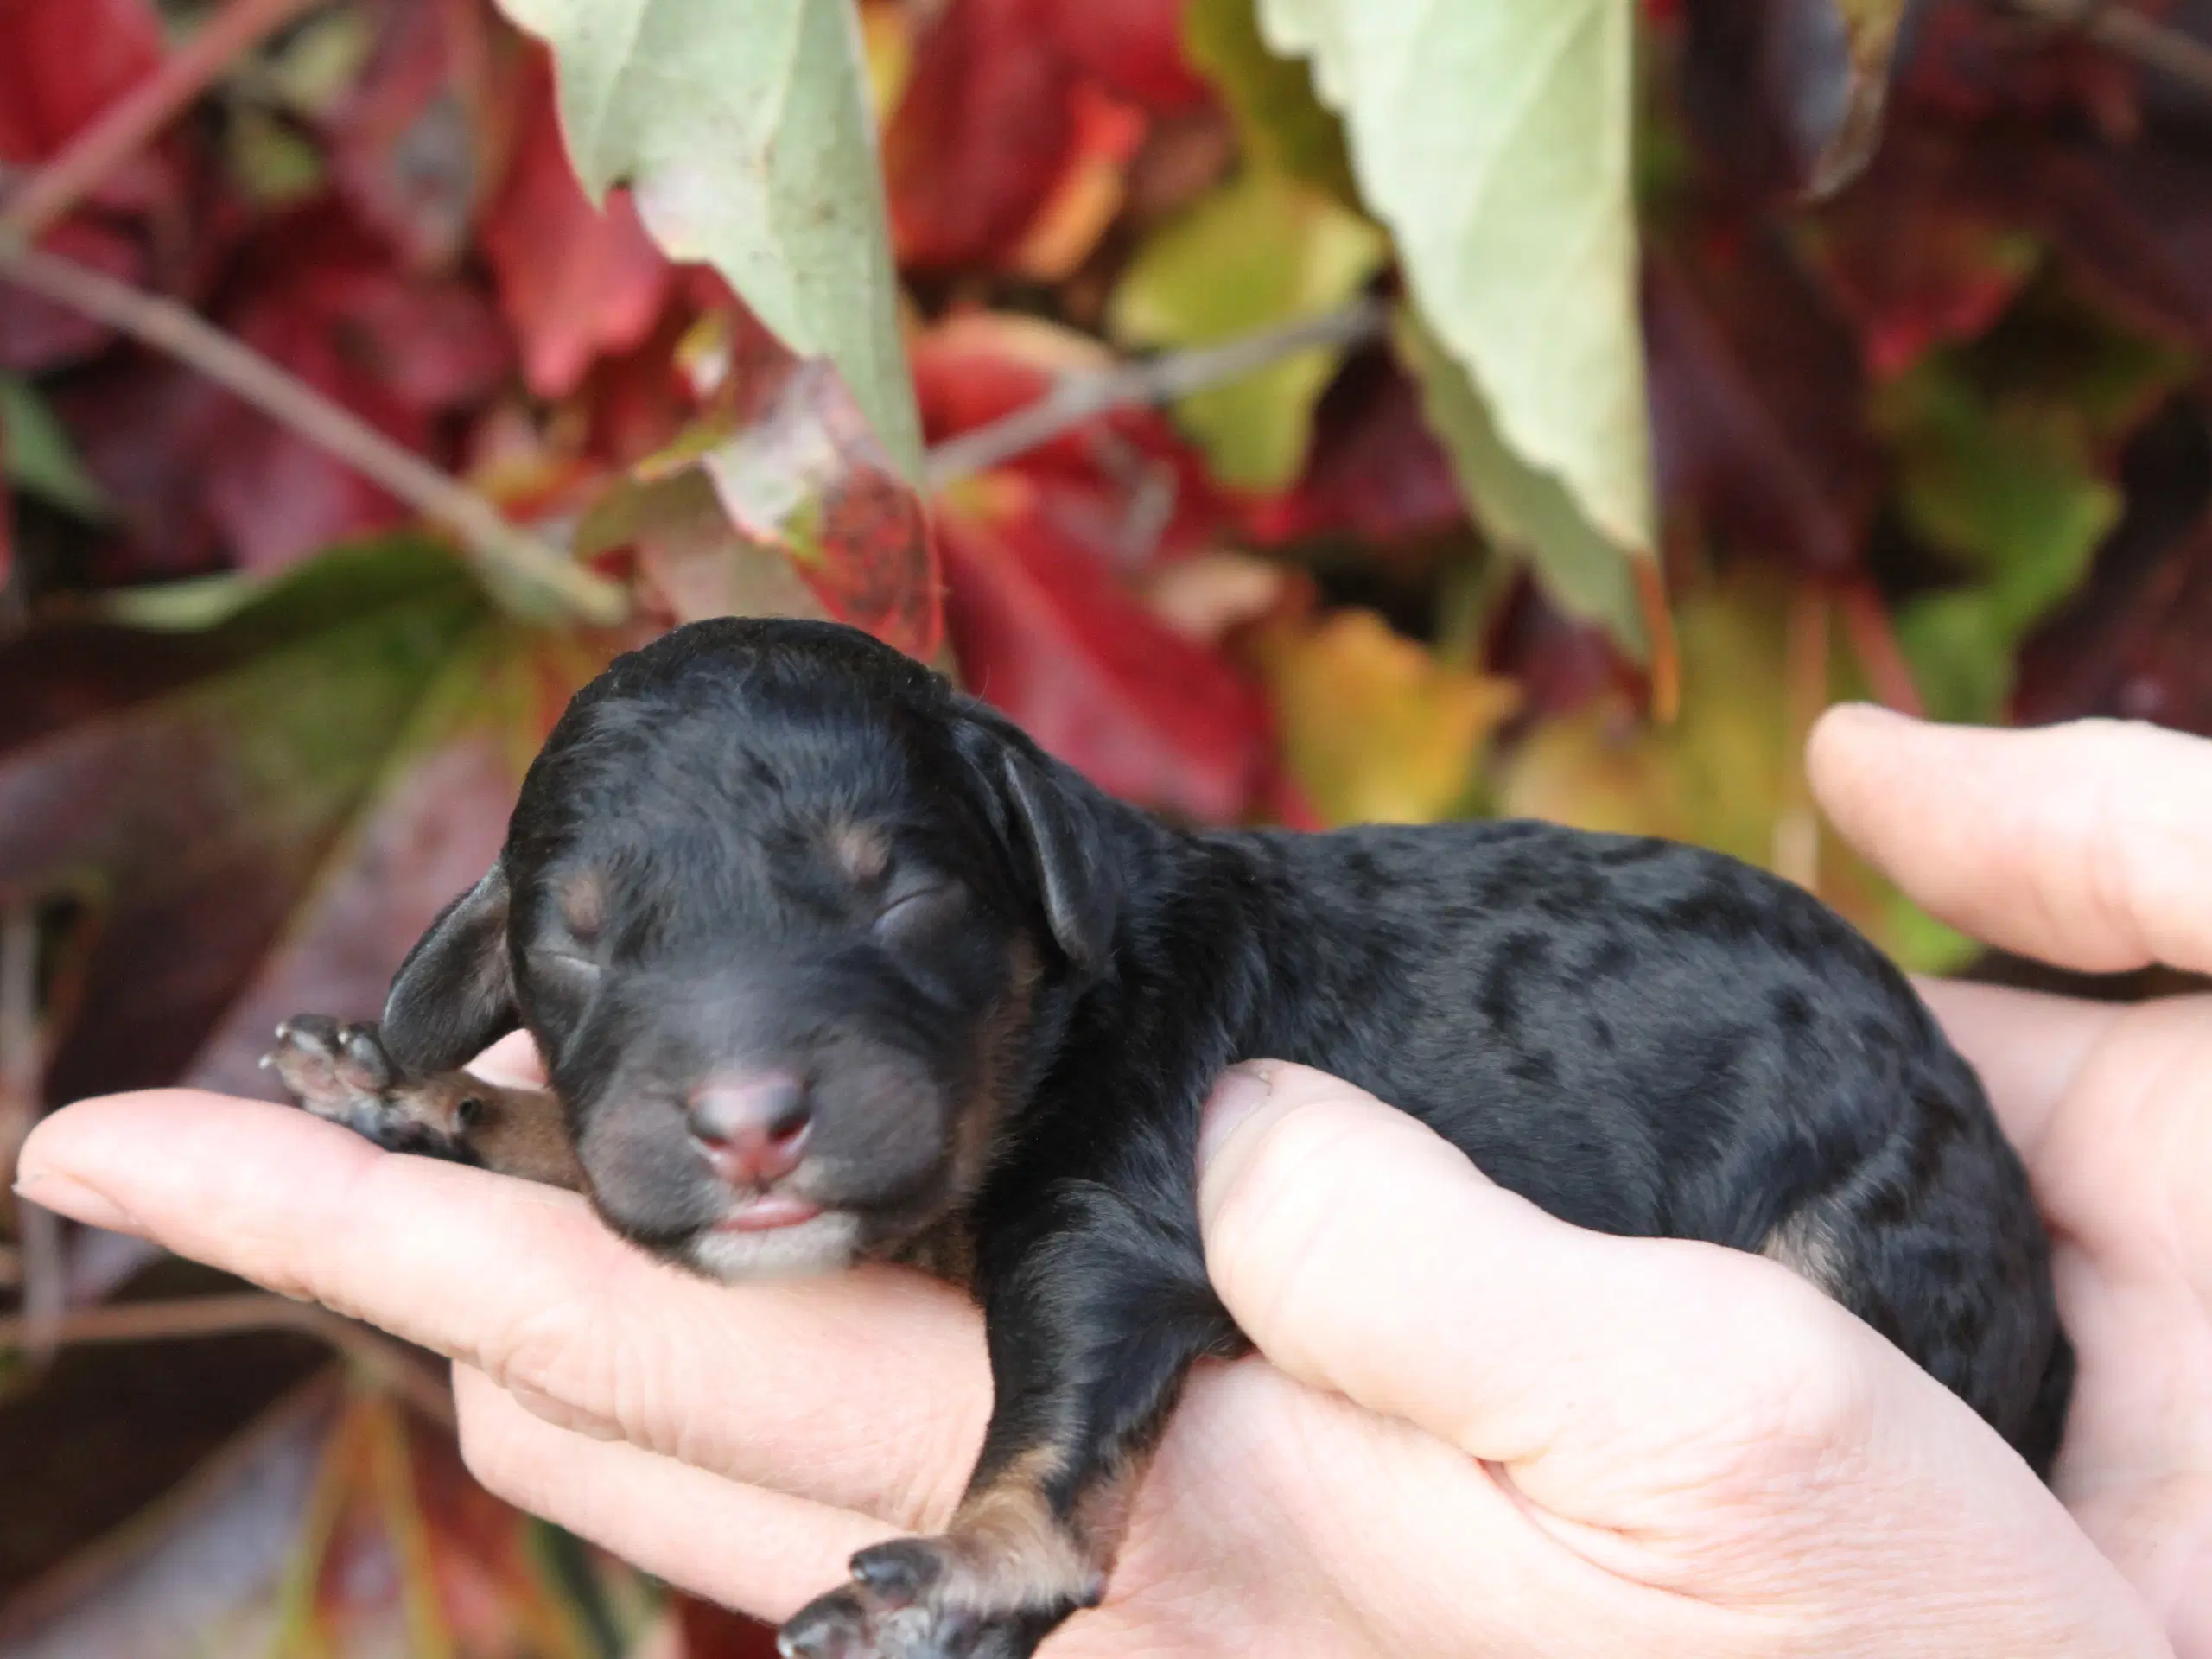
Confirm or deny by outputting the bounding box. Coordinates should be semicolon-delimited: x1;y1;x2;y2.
777;1537;1095;1659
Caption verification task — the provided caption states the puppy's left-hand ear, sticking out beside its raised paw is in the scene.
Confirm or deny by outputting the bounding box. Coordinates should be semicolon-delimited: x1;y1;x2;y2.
385;865;520;1077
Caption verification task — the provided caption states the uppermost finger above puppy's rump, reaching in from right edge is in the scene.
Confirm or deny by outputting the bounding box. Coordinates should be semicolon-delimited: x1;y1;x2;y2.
1808;706;2212;971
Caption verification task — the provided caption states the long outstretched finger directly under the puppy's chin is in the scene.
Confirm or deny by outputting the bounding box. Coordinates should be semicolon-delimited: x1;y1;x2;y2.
20;1090;991;1517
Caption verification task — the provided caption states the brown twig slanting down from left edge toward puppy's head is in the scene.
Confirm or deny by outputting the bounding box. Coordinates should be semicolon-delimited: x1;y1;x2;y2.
0;245;628;624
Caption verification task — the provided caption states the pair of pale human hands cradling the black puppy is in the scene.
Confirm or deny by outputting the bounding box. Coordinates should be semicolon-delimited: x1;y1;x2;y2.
22;708;2212;1659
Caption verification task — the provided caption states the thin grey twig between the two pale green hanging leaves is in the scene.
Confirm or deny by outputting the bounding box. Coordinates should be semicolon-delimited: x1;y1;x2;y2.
927;299;1387;489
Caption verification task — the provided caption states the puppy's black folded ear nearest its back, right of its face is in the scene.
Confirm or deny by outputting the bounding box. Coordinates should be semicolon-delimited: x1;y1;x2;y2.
957;708;1122;976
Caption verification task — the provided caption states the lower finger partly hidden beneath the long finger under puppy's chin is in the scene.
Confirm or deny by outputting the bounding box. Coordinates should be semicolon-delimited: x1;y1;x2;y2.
454;1365;896;1621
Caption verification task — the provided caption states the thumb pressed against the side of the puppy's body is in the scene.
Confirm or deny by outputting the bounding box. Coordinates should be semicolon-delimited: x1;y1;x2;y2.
1199;1062;1878;1496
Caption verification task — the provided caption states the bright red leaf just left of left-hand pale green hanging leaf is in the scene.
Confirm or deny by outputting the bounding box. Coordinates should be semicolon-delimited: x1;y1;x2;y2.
478;47;675;398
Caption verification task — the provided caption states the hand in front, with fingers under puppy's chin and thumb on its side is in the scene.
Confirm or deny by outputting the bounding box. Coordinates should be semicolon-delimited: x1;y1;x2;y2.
24;708;2192;1659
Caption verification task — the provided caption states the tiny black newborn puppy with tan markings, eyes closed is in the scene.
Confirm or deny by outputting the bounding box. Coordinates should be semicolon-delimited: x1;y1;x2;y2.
272;621;2073;1659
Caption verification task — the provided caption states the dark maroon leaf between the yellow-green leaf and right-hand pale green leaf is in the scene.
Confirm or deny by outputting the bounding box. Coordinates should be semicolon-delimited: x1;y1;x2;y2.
1248;352;1466;544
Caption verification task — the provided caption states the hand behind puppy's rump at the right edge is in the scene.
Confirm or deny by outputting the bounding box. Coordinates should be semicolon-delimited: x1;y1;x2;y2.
1812;708;2212;1659
